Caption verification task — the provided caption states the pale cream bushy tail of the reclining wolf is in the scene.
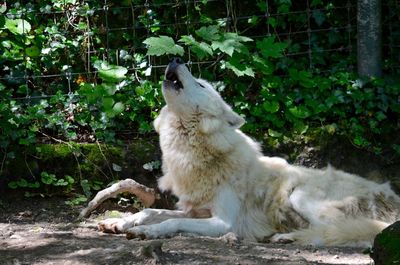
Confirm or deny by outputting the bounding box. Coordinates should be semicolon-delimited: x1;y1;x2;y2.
291;218;389;247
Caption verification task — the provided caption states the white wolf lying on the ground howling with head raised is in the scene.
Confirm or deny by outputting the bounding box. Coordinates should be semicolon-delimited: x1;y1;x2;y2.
99;58;400;246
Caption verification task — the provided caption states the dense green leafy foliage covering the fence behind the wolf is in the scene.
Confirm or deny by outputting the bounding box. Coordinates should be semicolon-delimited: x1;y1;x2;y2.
0;0;400;197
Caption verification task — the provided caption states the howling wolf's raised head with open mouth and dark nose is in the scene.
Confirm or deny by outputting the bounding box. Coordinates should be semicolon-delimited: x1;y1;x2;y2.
162;58;244;133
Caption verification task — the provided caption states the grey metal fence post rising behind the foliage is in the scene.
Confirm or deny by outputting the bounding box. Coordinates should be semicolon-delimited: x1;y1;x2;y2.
357;0;382;77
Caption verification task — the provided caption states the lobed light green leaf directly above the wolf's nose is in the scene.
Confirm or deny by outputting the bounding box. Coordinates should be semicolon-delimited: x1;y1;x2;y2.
143;36;185;56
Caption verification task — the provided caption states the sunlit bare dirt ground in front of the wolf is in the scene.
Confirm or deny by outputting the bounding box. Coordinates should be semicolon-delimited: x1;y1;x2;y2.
0;193;373;265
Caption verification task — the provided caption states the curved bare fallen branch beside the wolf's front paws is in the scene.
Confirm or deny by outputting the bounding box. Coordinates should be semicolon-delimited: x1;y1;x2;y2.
79;179;156;218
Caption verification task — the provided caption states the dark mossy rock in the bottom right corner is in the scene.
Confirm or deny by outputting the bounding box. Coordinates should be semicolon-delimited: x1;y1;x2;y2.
370;221;400;265
